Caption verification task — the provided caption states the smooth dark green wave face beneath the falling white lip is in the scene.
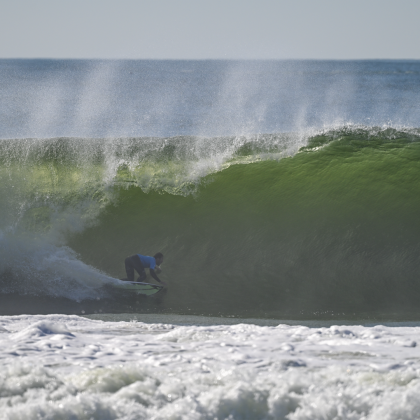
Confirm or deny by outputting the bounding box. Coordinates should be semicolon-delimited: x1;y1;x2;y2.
67;126;420;316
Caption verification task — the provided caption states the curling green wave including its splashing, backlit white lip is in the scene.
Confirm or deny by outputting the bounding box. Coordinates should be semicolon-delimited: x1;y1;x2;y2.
3;127;420;317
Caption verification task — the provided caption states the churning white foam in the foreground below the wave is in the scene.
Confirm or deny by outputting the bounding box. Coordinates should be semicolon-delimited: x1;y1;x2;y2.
0;315;420;420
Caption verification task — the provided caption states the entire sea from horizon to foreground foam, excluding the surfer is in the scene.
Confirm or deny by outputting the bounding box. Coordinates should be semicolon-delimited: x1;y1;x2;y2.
0;60;420;420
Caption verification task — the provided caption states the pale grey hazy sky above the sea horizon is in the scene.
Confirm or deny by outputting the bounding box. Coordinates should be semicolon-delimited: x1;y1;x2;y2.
0;0;420;59
